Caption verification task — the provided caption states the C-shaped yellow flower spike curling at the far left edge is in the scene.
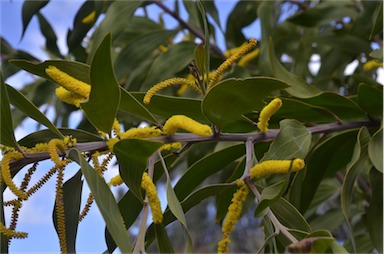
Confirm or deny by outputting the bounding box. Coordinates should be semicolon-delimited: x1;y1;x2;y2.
0;151;28;200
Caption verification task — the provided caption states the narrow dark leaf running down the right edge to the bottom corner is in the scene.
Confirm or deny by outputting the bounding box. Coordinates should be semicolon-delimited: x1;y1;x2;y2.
366;170;383;253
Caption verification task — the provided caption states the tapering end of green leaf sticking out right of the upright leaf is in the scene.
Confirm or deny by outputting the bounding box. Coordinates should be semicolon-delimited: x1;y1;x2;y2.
119;87;157;124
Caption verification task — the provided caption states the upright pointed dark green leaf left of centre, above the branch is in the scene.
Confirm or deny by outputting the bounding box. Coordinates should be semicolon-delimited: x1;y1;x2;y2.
81;34;120;133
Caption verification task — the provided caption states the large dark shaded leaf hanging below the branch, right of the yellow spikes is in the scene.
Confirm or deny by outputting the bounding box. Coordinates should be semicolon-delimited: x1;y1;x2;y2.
300;130;357;212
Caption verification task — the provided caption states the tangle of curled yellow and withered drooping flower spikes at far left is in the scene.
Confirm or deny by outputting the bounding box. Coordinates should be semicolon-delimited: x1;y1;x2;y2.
0;136;76;248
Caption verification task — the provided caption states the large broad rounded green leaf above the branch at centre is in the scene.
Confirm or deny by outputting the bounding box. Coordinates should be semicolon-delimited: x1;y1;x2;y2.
202;77;288;128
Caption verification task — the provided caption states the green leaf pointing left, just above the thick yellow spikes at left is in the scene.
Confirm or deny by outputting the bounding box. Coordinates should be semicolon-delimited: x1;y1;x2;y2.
10;60;91;84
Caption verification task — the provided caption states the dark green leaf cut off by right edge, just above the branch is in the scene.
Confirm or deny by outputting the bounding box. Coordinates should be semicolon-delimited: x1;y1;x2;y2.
357;83;383;117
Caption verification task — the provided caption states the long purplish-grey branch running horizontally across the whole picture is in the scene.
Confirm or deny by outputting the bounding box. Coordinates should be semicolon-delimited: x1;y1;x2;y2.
10;120;380;174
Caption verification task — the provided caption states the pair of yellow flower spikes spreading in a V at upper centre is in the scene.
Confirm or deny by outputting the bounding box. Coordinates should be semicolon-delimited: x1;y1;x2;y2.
143;38;259;104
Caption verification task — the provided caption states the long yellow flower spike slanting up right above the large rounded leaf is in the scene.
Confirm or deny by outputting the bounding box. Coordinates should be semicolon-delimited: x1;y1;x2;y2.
208;38;257;90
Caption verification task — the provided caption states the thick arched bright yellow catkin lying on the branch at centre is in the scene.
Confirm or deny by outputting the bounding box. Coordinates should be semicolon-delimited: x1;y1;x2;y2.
163;115;212;137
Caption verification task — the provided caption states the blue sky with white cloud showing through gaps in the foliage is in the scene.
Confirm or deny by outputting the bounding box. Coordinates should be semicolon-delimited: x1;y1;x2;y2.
0;0;383;253
